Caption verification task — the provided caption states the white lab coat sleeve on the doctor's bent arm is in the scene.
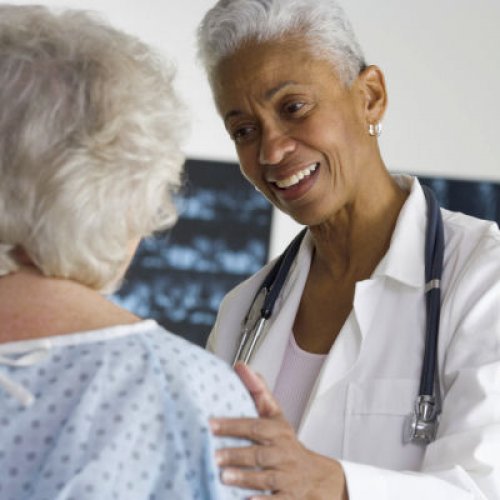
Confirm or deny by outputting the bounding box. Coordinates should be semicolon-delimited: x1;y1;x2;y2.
341;231;500;500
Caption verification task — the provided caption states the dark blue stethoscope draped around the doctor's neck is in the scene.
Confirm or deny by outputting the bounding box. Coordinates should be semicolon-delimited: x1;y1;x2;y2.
233;186;444;444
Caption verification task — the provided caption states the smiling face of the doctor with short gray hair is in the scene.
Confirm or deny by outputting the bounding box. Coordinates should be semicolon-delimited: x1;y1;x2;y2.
213;39;371;225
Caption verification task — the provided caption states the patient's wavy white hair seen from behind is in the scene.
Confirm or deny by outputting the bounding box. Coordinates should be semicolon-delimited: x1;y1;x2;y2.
0;6;184;291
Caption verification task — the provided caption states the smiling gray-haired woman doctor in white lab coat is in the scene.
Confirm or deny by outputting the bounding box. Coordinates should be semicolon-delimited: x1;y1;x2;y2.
199;0;500;500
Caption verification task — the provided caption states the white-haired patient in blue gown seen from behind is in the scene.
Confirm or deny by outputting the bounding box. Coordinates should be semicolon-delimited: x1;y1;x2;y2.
0;6;255;500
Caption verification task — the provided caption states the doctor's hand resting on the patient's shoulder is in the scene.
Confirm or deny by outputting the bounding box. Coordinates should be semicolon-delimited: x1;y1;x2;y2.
210;363;348;500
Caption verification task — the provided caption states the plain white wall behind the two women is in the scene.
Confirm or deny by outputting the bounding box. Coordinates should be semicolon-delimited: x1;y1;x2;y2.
9;0;500;255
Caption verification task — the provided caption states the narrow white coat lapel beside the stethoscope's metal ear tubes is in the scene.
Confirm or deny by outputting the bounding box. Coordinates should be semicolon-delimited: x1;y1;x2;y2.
250;233;312;390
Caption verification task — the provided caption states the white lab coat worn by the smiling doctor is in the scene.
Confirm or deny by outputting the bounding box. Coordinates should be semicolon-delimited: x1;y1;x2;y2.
207;176;500;500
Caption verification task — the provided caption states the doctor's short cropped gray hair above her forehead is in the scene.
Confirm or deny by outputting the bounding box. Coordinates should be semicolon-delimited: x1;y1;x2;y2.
198;0;366;86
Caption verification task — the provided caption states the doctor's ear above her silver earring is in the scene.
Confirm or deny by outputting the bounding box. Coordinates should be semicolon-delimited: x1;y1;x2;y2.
356;65;387;123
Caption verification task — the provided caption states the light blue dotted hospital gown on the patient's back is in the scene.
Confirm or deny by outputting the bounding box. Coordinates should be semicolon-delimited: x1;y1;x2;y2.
0;320;255;500
